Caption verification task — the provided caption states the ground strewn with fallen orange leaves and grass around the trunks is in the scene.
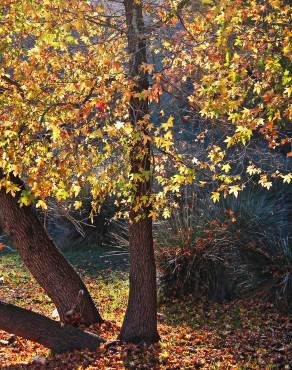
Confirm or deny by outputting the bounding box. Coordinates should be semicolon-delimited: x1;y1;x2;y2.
0;249;292;370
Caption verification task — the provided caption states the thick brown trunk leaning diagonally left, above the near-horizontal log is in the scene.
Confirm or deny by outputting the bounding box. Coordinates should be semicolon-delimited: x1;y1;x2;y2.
0;174;103;325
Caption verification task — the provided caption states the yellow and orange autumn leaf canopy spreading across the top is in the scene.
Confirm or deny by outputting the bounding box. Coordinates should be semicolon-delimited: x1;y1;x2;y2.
1;0;291;217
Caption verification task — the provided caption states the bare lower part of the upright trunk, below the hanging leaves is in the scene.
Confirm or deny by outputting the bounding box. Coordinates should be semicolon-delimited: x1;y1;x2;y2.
120;219;159;343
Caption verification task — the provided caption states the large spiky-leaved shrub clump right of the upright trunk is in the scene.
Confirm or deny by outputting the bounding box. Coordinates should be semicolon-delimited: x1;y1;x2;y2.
155;186;292;309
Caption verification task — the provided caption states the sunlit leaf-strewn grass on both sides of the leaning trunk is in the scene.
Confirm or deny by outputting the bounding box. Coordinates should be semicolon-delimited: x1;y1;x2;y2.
0;247;128;320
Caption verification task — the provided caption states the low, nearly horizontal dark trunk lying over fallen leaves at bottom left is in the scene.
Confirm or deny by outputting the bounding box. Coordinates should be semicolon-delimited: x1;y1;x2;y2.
0;302;105;353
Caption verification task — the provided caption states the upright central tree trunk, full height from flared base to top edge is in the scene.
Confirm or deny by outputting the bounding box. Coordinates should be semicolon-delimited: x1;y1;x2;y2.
119;0;159;343
